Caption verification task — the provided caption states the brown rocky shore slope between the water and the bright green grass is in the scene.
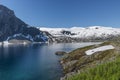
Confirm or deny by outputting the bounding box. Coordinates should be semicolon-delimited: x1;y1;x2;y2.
60;41;120;80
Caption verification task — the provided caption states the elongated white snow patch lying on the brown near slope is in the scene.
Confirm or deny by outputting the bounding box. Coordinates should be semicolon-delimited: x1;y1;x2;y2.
85;45;115;55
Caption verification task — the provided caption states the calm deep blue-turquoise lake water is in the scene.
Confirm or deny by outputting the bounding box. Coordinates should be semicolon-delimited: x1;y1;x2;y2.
0;42;98;80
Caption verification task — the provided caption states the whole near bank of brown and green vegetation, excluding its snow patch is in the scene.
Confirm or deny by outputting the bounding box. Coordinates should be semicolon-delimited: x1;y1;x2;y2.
62;40;120;80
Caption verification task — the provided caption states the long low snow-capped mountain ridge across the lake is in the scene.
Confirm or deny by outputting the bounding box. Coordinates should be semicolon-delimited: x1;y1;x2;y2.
39;26;120;42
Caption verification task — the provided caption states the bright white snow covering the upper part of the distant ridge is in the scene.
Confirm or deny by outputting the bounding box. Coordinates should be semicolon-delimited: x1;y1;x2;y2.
39;26;120;38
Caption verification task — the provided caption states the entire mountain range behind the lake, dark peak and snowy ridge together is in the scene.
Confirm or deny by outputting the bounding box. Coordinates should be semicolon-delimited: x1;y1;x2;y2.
0;5;120;43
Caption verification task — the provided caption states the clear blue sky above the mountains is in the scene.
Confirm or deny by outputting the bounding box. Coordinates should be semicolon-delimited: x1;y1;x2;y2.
0;0;120;27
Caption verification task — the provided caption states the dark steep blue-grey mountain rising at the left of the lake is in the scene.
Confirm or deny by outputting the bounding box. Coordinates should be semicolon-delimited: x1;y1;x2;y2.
0;5;47;42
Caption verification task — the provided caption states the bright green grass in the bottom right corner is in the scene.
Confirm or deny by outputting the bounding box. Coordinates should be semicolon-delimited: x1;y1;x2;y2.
66;56;120;80
